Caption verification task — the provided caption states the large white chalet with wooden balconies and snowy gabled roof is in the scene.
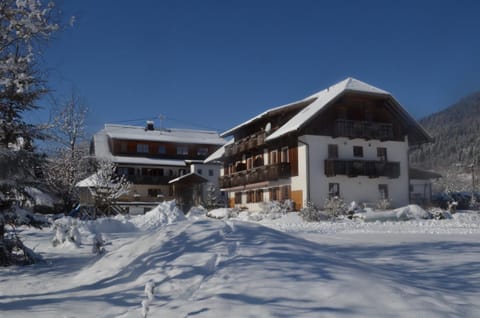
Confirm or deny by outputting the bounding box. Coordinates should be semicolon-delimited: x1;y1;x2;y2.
207;78;431;209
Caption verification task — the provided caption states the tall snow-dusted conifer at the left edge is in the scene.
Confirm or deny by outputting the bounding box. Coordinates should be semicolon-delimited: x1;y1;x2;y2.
0;0;58;265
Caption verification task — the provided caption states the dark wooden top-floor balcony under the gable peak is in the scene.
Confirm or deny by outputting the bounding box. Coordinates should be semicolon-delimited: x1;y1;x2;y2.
334;119;394;140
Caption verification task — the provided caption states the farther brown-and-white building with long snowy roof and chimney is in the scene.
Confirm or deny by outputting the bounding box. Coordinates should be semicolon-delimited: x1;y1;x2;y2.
87;122;225;209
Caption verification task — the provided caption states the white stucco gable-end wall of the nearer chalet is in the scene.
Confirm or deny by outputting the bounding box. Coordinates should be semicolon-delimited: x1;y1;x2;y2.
300;135;409;206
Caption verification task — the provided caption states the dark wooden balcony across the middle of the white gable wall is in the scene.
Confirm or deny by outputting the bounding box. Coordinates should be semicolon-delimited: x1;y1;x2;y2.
325;159;400;179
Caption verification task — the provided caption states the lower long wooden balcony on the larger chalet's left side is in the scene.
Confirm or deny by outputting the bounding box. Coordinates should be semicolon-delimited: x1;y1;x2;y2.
220;162;290;188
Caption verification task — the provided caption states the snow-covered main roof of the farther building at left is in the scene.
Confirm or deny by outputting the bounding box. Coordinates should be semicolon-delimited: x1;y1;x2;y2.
103;124;225;145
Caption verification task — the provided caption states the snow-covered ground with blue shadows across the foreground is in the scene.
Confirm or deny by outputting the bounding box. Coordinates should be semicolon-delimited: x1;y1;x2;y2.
0;203;480;318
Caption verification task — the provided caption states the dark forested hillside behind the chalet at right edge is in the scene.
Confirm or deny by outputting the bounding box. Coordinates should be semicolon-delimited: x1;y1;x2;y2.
410;92;480;173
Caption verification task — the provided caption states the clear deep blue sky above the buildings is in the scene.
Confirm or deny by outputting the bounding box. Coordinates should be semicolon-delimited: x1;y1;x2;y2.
32;0;480;133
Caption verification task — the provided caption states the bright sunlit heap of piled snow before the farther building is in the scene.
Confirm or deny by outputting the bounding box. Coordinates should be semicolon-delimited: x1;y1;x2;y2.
130;201;186;231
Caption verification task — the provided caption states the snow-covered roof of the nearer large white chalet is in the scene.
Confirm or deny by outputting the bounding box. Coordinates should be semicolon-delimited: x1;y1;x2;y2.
266;77;391;141
